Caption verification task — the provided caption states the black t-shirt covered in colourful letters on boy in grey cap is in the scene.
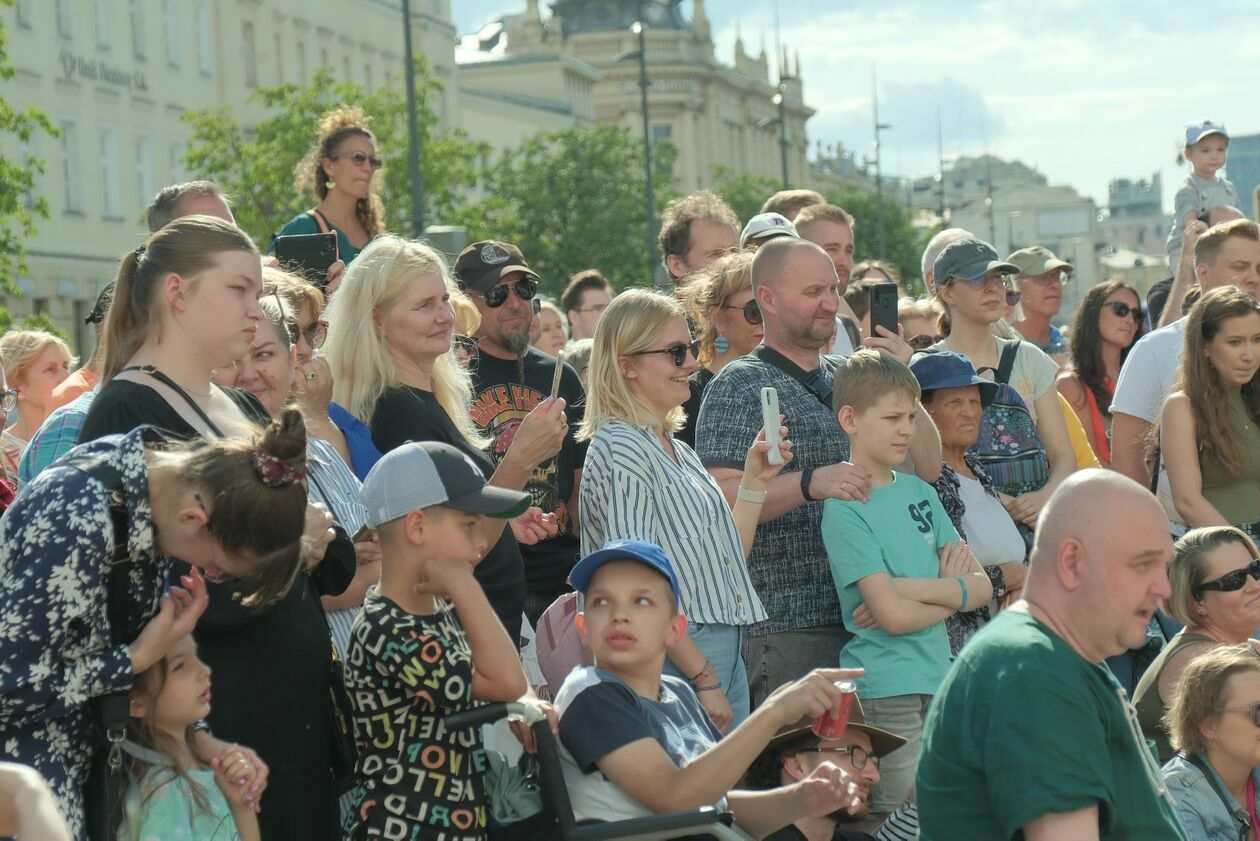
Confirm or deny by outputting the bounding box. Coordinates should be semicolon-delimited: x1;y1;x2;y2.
345;588;486;841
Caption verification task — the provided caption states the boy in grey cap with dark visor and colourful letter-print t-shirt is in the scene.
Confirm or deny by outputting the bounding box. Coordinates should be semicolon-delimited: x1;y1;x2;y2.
344;441;529;841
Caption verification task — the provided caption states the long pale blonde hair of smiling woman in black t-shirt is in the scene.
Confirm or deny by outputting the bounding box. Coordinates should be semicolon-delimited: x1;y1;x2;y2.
324;235;490;449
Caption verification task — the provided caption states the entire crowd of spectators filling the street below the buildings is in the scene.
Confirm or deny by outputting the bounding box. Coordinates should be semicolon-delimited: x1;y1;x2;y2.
0;107;1260;841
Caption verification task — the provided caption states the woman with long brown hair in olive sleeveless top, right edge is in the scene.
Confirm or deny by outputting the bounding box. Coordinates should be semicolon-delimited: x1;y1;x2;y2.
1158;286;1260;538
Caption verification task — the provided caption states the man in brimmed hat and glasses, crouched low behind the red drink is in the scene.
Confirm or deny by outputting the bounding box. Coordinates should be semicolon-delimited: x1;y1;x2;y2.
747;695;906;841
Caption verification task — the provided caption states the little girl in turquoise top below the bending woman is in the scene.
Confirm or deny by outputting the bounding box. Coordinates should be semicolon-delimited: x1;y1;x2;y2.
118;634;261;841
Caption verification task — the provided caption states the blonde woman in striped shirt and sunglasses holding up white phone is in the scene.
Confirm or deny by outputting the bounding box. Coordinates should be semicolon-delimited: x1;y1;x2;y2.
578;289;791;731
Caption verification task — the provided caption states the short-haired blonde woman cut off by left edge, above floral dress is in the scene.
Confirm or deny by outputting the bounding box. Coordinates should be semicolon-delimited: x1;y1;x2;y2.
0;330;76;479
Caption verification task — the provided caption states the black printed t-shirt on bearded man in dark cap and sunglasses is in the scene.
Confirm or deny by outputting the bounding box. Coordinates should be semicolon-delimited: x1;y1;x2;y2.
469;348;586;595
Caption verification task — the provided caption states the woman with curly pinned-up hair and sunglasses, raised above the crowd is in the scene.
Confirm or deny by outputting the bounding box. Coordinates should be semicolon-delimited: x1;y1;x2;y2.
276;105;386;264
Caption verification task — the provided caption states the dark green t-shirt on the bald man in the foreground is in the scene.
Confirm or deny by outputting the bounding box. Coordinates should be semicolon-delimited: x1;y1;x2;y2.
916;610;1186;841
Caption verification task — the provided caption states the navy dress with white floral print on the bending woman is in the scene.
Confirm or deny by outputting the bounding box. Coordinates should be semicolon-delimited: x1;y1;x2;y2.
0;427;169;837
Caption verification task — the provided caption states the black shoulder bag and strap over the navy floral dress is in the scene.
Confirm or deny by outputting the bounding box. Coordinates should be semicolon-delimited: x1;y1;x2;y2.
72;456;134;841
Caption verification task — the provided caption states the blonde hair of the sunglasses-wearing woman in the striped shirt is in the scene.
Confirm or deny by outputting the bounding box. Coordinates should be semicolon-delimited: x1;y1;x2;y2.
577;289;687;441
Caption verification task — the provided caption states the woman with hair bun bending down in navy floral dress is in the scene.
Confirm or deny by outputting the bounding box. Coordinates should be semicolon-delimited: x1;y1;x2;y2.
0;411;306;837
